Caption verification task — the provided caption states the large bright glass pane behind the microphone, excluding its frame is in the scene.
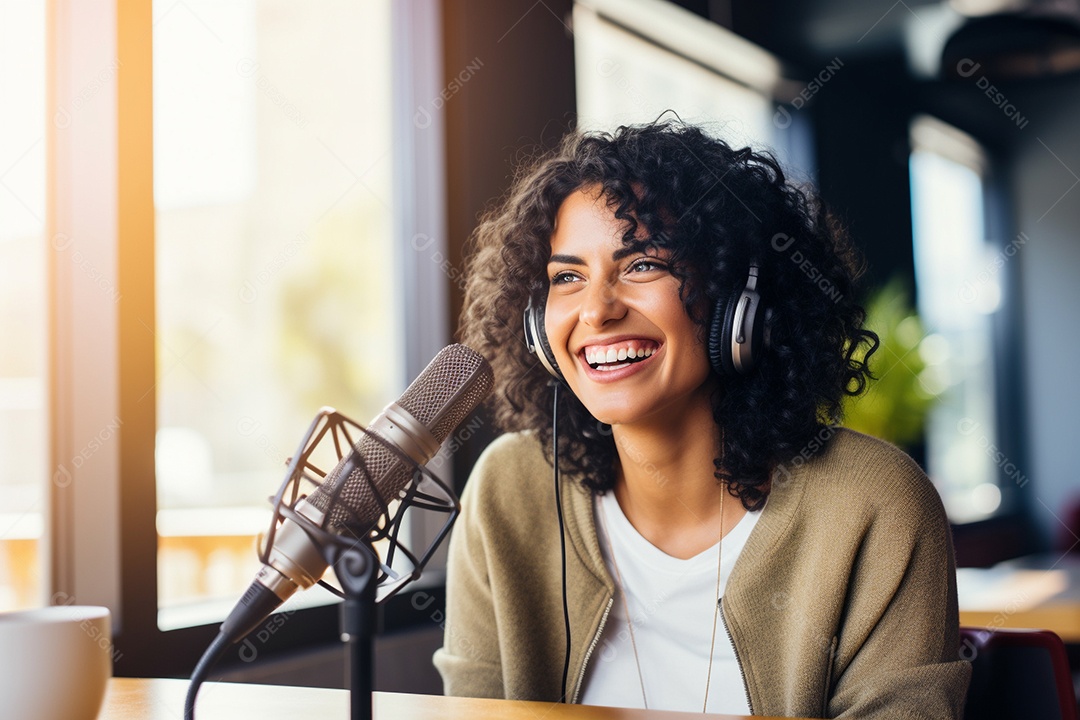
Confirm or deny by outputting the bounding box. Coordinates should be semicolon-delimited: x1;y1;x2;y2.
153;0;404;628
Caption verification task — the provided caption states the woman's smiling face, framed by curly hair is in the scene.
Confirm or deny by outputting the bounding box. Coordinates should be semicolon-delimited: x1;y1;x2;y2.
544;189;710;425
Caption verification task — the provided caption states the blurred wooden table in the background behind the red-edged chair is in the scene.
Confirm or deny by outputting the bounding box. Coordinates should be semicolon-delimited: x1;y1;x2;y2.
956;555;1080;642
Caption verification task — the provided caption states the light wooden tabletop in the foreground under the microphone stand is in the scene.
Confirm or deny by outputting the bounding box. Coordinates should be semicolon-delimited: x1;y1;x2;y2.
97;678;807;720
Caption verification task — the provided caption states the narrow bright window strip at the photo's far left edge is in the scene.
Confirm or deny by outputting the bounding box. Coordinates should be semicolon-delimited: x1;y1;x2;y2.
0;0;48;611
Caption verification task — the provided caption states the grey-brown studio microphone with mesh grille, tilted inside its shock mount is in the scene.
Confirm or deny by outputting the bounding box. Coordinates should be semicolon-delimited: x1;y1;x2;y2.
219;344;494;643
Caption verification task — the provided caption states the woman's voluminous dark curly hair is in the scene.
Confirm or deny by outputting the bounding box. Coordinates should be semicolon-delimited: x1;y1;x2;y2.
460;121;878;510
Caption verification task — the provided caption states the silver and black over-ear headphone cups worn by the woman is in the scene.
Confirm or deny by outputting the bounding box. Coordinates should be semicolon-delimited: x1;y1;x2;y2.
524;263;772;380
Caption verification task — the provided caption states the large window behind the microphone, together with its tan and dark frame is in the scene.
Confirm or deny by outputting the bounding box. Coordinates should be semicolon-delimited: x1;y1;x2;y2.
38;0;448;676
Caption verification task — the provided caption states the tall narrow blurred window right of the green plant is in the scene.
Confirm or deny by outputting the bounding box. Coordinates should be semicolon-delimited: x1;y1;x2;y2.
910;117;1002;522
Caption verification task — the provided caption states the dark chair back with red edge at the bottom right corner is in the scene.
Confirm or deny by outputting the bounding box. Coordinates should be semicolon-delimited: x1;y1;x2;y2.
960;627;1077;720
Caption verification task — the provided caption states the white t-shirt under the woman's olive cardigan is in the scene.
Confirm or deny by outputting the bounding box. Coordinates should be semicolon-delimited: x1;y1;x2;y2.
581;492;761;715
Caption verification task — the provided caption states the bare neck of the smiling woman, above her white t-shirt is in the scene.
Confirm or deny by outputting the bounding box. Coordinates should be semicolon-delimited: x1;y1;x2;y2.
612;402;746;558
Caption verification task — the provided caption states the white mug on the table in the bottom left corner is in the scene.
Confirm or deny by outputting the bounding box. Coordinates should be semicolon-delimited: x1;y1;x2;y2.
0;606;112;720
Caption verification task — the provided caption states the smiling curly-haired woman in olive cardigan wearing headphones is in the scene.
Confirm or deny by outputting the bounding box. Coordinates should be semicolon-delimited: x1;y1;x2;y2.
435;123;970;718
